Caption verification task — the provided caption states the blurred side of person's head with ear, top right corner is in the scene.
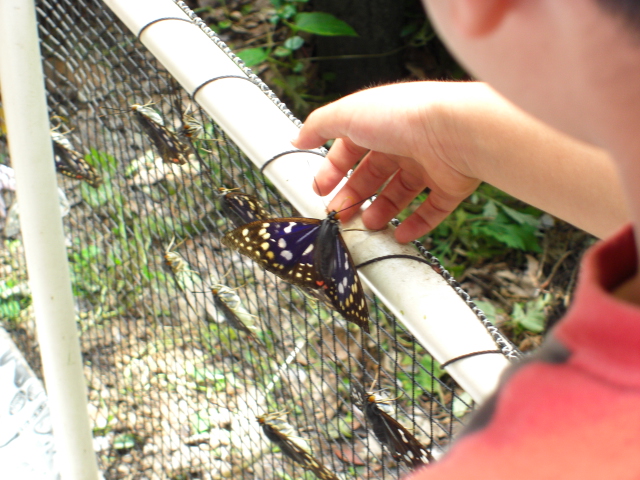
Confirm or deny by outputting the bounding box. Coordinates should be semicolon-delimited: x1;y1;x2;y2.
423;0;640;152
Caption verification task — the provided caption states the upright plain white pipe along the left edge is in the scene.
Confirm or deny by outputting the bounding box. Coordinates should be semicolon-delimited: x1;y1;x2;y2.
0;0;98;480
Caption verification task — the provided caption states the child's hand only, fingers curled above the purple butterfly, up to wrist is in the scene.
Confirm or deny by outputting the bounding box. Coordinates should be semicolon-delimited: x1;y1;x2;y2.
294;82;489;243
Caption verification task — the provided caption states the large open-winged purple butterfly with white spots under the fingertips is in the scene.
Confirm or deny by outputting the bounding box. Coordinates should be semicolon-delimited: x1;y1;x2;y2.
222;210;369;332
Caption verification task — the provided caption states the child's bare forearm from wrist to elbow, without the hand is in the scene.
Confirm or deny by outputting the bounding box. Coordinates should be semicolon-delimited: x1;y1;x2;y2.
430;84;629;237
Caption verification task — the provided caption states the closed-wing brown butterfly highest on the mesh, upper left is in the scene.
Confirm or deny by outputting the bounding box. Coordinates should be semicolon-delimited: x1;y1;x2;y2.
131;103;191;165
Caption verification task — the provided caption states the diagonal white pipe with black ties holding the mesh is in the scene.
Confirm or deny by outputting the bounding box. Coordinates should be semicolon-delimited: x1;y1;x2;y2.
105;0;509;402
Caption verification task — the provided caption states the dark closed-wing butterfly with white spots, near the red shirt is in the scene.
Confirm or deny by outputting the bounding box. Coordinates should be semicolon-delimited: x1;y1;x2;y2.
354;389;433;468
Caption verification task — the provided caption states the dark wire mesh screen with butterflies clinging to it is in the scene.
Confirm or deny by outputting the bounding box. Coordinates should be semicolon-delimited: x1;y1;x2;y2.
0;0;510;479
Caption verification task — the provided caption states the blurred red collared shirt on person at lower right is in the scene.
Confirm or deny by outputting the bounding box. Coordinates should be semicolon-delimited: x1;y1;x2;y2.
406;227;640;480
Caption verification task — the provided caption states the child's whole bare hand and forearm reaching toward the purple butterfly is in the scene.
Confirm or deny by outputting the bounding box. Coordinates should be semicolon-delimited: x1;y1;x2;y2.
293;82;629;243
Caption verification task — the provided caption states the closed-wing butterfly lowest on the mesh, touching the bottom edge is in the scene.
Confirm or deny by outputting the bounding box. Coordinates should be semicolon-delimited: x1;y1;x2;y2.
256;412;338;480
